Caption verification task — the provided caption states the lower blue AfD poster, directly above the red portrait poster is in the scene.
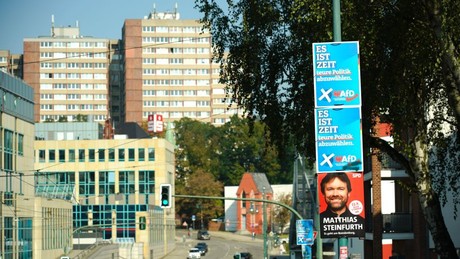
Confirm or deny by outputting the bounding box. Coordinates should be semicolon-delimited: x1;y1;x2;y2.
315;107;363;173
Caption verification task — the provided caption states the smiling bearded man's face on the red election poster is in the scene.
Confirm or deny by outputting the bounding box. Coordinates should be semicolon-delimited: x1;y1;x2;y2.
324;178;350;213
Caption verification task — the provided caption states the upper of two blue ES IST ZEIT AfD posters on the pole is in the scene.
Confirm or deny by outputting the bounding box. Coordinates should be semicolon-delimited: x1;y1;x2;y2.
313;41;361;107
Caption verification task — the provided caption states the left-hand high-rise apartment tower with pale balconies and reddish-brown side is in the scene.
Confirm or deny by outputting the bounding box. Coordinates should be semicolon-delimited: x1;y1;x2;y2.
24;20;118;123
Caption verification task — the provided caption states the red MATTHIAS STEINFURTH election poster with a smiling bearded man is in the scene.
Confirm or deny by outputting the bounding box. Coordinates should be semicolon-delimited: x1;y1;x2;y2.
317;172;365;238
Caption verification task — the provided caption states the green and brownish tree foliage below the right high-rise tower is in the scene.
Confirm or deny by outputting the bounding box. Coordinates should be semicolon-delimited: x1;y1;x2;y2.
174;116;293;223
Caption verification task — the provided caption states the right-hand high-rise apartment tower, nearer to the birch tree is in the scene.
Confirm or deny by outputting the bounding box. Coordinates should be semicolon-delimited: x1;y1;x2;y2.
121;11;243;126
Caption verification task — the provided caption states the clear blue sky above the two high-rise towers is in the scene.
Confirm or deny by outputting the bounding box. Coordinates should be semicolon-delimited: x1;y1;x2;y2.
0;0;210;54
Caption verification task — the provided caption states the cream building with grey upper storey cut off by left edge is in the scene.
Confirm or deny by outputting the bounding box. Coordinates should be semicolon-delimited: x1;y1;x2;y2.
0;71;72;258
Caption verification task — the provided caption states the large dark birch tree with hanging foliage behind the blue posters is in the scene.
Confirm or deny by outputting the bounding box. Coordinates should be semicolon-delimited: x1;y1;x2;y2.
195;0;460;258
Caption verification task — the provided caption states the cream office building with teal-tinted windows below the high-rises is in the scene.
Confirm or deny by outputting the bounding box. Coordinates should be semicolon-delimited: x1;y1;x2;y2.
34;136;175;258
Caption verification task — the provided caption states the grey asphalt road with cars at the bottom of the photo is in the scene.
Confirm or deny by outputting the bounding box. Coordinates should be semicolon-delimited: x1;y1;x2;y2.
164;230;276;259
